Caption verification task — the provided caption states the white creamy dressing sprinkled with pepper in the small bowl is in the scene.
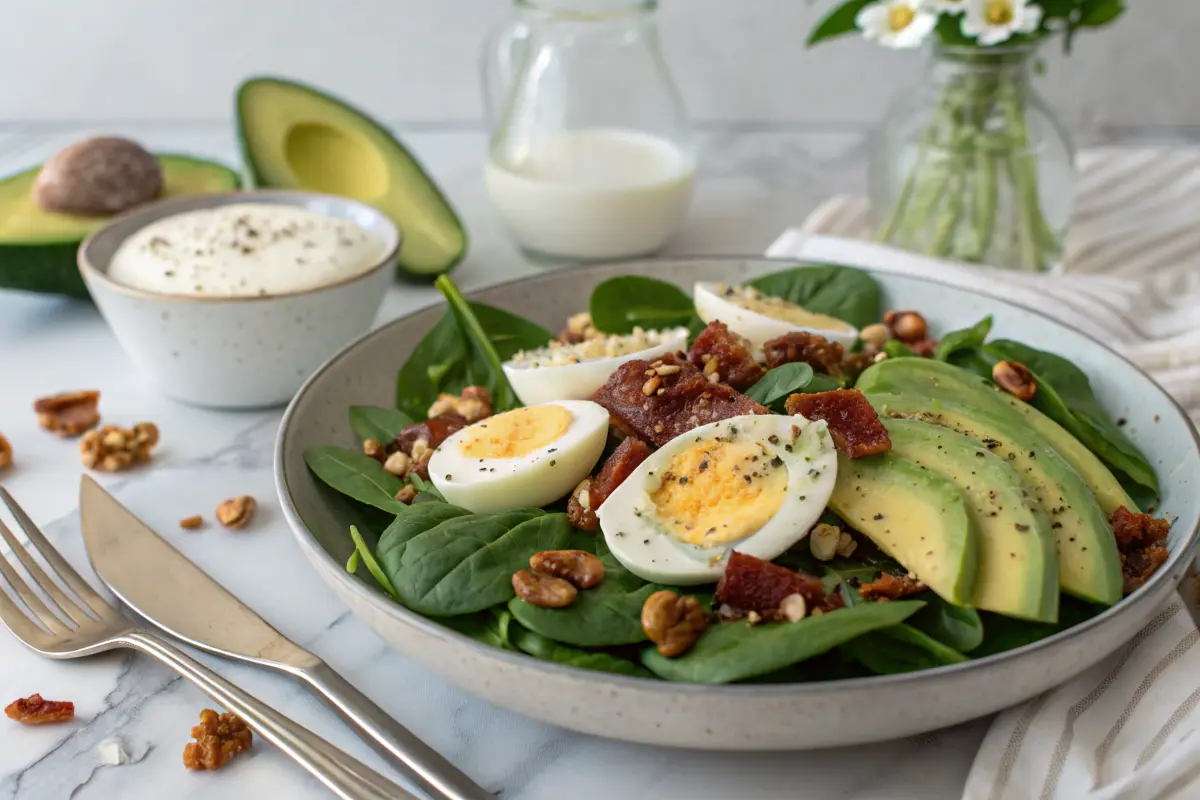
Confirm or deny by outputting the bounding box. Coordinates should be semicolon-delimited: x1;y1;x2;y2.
108;203;385;297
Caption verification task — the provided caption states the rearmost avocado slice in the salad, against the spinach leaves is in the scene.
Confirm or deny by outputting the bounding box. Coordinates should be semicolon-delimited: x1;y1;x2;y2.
856;359;1138;517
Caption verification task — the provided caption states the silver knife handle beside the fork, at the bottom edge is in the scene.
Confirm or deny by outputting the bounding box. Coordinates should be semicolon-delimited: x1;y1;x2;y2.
292;660;496;800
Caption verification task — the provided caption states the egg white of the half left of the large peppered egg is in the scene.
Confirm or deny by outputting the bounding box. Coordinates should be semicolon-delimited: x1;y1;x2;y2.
430;401;608;513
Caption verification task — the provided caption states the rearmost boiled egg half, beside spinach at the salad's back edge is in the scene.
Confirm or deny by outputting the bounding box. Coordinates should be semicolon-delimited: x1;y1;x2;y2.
692;283;858;360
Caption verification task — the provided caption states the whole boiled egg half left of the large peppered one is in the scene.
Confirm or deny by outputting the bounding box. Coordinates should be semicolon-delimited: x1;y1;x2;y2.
430;401;608;513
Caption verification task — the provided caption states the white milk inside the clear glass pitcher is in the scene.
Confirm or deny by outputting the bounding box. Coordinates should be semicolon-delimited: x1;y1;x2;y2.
484;128;695;259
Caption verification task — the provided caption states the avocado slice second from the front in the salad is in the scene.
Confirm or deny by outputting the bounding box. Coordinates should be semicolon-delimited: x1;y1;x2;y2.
884;420;1058;622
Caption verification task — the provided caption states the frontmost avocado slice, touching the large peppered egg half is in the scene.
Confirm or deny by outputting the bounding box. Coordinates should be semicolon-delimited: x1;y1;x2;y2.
829;452;979;606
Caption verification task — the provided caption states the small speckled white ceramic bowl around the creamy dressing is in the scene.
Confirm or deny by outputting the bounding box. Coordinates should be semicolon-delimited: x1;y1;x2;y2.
79;192;400;408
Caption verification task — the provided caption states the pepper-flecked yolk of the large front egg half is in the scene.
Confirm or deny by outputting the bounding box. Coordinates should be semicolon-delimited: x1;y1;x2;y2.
649;440;787;547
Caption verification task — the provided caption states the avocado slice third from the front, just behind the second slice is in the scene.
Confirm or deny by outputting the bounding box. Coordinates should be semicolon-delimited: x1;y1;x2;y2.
866;395;1121;606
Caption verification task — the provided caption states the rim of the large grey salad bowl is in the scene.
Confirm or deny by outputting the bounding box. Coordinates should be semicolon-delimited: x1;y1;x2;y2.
272;255;1200;699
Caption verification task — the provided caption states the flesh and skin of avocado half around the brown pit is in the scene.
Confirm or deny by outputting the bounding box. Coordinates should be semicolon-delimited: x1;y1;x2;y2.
0;155;240;297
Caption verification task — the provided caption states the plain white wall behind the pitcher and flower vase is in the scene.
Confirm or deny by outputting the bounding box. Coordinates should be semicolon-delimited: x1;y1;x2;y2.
0;0;1185;130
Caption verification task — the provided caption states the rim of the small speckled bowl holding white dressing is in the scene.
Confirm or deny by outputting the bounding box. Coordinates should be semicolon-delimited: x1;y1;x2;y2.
76;190;404;304
